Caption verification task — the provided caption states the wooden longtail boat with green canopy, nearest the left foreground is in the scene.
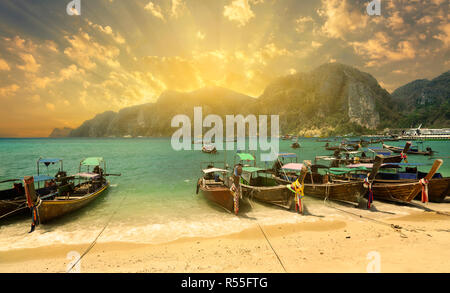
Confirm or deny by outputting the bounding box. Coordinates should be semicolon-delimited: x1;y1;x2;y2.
24;157;120;225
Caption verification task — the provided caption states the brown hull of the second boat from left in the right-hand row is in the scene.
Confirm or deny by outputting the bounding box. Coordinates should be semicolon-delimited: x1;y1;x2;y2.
241;183;295;210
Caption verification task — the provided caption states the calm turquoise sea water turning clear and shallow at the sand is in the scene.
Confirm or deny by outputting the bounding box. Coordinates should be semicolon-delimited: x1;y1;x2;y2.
0;138;450;250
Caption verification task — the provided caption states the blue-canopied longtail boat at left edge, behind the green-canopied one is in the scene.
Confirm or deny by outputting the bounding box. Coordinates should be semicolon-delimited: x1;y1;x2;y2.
0;158;66;219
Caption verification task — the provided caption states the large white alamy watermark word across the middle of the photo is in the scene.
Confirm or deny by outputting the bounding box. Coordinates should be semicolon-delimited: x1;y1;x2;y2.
171;107;280;161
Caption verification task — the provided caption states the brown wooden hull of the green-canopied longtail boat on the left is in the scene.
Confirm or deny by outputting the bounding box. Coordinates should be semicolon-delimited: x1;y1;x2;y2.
37;181;109;223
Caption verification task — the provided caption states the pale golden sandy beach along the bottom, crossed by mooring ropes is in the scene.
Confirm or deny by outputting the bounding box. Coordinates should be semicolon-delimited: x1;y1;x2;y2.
0;198;450;273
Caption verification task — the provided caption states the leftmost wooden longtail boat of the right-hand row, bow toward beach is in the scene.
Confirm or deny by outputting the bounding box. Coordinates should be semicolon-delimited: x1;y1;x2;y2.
197;165;240;215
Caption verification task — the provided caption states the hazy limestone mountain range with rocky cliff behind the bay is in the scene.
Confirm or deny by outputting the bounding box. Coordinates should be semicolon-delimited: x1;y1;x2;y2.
52;63;450;137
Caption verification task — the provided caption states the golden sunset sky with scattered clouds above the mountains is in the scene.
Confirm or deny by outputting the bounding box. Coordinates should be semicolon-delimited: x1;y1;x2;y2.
0;0;450;137
